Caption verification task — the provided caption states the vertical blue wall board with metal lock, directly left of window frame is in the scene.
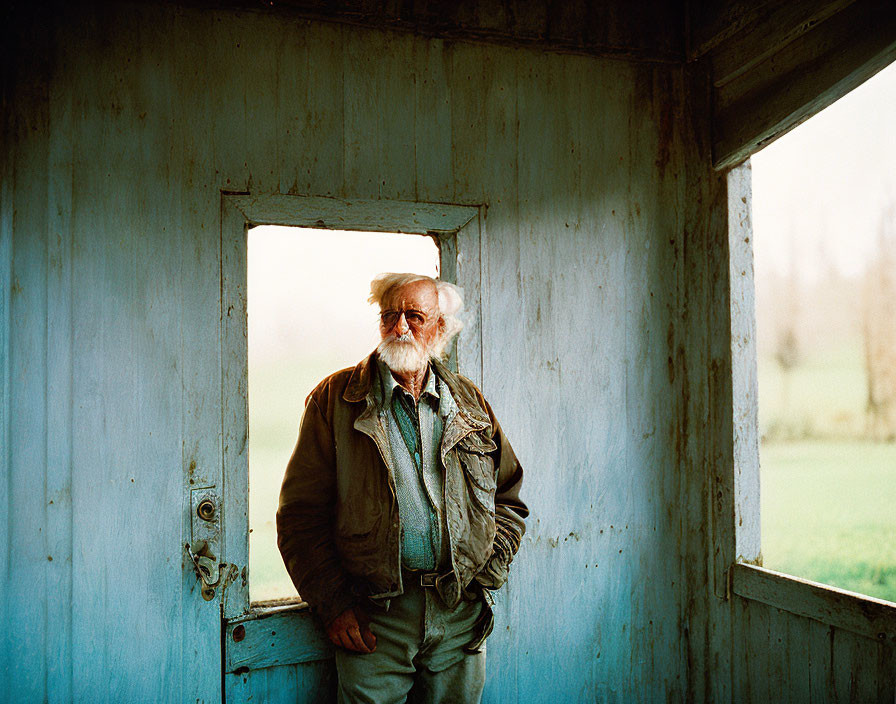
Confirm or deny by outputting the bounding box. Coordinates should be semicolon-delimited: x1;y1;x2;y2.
172;5;232;701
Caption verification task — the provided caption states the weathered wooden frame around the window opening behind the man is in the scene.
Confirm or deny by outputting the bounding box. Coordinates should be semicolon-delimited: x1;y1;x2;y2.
220;192;484;628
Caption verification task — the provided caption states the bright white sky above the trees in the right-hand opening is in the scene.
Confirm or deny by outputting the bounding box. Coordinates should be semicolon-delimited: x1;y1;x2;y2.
751;59;896;281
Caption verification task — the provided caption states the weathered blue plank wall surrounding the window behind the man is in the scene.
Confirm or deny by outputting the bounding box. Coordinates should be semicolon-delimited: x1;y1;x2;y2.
0;3;889;702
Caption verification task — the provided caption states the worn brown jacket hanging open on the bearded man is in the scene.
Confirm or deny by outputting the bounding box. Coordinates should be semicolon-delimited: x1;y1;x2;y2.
277;353;529;624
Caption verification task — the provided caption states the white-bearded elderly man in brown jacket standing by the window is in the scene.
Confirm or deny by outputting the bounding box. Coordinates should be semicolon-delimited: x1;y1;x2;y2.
277;274;528;703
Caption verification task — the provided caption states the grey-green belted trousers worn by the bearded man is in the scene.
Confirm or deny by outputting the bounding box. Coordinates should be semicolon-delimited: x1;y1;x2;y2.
336;579;485;704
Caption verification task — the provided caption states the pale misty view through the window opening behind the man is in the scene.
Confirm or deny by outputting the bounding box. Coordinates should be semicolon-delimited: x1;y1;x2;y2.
247;226;439;602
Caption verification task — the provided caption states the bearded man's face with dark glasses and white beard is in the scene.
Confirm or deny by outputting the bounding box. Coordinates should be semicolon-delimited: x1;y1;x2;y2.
377;281;442;372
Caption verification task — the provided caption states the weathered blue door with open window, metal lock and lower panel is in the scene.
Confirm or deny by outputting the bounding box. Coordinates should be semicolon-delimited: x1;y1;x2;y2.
213;194;481;702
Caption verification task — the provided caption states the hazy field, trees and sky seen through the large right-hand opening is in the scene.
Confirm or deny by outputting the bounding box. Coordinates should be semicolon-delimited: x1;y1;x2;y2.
751;60;896;602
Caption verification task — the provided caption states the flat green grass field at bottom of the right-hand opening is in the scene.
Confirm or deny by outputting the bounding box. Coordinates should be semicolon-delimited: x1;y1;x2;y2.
760;441;896;601
